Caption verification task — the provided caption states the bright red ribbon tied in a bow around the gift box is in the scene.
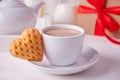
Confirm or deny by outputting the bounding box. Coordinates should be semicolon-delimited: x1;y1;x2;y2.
78;0;120;45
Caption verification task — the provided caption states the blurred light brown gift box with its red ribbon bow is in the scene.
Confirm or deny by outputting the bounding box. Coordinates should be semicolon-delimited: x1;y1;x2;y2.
77;0;120;43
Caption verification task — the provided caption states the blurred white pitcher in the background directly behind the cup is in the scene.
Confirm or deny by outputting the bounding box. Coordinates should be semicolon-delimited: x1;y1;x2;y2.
54;0;77;25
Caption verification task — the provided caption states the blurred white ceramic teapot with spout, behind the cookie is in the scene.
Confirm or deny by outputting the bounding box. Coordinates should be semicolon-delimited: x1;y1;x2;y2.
0;0;43;35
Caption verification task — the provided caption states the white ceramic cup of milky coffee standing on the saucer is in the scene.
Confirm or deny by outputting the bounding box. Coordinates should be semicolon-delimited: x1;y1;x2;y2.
41;24;85;66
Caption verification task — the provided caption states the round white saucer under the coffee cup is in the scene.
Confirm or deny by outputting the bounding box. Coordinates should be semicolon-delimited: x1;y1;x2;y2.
29;47;100;75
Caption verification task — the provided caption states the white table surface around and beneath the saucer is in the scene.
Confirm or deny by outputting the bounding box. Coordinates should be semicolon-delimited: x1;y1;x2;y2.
0;17;120;80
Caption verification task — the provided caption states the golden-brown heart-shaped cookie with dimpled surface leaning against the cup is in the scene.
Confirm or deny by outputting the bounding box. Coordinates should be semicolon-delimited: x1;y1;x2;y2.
9;28;43;61
